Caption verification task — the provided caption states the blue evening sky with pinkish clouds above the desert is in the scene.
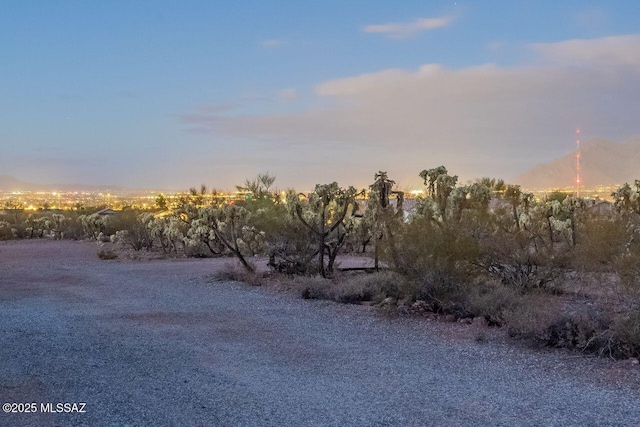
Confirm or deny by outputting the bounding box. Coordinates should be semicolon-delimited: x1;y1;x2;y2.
0;0;640;190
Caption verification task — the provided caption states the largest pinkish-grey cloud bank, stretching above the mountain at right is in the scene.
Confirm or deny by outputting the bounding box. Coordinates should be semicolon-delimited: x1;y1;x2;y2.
178;35;640;186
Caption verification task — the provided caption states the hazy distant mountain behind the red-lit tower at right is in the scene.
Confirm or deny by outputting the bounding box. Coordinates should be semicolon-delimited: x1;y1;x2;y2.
514;139;640;189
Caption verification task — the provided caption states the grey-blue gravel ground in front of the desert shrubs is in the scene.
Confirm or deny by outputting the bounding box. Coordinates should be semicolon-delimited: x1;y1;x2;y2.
0;241;640;426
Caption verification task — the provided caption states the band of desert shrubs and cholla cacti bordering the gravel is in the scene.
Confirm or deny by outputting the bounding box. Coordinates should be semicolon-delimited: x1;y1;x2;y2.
0;166;640;357
